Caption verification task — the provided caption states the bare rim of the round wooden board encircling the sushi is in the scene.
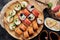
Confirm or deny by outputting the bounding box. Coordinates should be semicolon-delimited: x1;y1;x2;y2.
0;0;44;39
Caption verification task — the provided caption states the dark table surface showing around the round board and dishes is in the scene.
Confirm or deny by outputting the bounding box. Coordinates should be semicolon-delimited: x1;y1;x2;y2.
0;0;60;40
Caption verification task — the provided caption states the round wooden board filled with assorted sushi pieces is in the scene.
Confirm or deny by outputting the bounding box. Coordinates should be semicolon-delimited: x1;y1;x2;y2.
0;0;44;40
